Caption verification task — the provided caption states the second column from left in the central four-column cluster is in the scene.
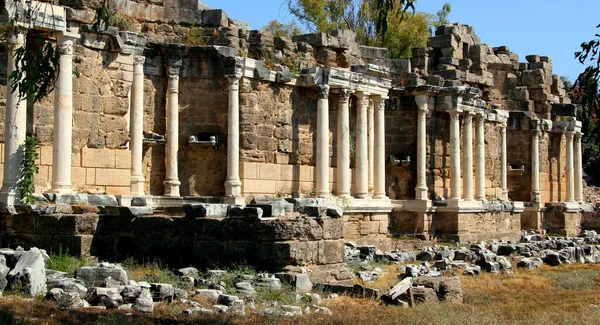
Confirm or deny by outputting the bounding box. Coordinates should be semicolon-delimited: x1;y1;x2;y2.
337;89;352;197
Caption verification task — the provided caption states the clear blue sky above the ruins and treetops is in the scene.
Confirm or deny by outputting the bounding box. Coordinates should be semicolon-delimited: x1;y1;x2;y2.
203;0;600;80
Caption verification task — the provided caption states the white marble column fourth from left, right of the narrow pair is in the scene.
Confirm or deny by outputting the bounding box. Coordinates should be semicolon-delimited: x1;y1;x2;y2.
164;67;181;197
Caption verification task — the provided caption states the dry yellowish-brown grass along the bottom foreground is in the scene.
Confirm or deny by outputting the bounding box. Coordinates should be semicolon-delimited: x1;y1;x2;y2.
0;264;600;325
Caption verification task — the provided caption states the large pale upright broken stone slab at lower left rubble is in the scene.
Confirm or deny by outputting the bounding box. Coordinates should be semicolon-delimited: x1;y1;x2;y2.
7;247;47;296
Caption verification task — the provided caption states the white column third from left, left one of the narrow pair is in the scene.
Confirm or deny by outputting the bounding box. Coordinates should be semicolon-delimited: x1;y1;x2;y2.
129;55;146;195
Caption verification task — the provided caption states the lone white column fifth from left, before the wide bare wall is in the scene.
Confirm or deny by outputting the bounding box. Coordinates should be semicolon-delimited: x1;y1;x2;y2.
225;71;242;198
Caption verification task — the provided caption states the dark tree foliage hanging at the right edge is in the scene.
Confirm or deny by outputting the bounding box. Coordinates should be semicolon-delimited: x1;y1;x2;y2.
572;25;600;185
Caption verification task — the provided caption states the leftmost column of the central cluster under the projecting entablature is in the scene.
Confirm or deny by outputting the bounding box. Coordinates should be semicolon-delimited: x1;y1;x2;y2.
316;85;329;197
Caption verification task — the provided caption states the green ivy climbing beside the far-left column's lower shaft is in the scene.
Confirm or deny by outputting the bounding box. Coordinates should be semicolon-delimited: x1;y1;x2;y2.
17;136;39;204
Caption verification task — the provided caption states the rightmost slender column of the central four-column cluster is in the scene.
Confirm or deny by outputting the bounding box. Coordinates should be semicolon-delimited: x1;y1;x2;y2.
373;96;388;199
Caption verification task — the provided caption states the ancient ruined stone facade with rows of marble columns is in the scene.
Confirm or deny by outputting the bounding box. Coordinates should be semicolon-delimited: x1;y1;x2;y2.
0;0;600;274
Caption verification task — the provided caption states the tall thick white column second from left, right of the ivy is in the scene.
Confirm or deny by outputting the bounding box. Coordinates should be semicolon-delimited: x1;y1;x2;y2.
51;34;74;193
